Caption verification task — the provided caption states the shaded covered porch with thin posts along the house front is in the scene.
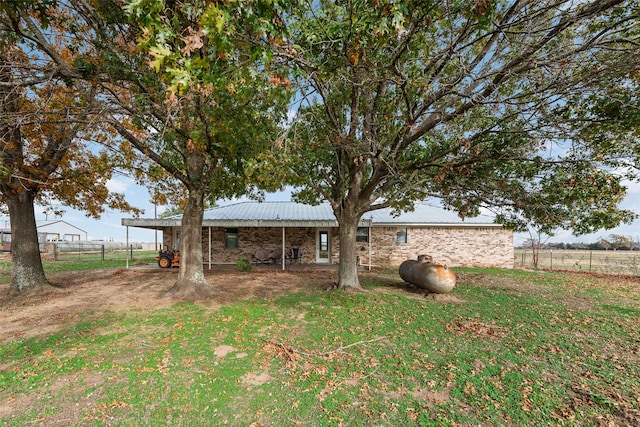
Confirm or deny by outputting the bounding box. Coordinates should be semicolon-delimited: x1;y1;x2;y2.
122;207;371;270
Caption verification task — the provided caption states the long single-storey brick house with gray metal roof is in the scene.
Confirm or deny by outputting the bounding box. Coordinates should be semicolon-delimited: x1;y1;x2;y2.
122;201;513;268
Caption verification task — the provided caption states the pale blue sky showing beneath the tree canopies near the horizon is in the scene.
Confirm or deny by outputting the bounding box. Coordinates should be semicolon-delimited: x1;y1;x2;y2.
0;176;640;246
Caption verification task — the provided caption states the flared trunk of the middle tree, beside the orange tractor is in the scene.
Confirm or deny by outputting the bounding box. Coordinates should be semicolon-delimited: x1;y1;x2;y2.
168;189;214;300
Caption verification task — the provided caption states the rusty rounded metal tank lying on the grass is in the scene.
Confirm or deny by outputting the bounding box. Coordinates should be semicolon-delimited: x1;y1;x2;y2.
398;255;456;294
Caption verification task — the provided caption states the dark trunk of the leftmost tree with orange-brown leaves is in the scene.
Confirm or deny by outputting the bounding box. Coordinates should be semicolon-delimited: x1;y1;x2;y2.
4;191;50;293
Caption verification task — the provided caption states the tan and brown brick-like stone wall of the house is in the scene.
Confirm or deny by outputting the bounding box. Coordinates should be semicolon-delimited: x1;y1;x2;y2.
163;226;514;268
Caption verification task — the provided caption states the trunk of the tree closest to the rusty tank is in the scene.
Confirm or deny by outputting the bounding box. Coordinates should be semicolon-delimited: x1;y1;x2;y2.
336;210;362;290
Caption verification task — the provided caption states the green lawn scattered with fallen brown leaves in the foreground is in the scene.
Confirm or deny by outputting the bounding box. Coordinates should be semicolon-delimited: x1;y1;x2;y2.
0;269;640;426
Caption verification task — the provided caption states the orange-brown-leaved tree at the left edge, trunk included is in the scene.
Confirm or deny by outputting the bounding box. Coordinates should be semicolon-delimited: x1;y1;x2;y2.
0;1;139;292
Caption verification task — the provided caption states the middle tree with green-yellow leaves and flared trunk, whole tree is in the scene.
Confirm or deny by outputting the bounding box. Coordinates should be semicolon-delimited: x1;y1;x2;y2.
96;0;287;299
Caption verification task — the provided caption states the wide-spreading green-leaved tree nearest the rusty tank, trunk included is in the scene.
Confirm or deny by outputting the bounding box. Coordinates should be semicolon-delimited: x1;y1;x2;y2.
275;0;638;288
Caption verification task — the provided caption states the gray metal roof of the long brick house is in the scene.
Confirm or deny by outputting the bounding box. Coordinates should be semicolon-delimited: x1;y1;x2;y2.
122;201;500;228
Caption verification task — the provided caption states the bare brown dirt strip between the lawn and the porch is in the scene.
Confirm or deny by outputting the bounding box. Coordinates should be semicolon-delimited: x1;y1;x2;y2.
0;268;337;345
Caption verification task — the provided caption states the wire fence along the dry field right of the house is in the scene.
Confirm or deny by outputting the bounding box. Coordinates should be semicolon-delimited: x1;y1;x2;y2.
514;249;640;276
